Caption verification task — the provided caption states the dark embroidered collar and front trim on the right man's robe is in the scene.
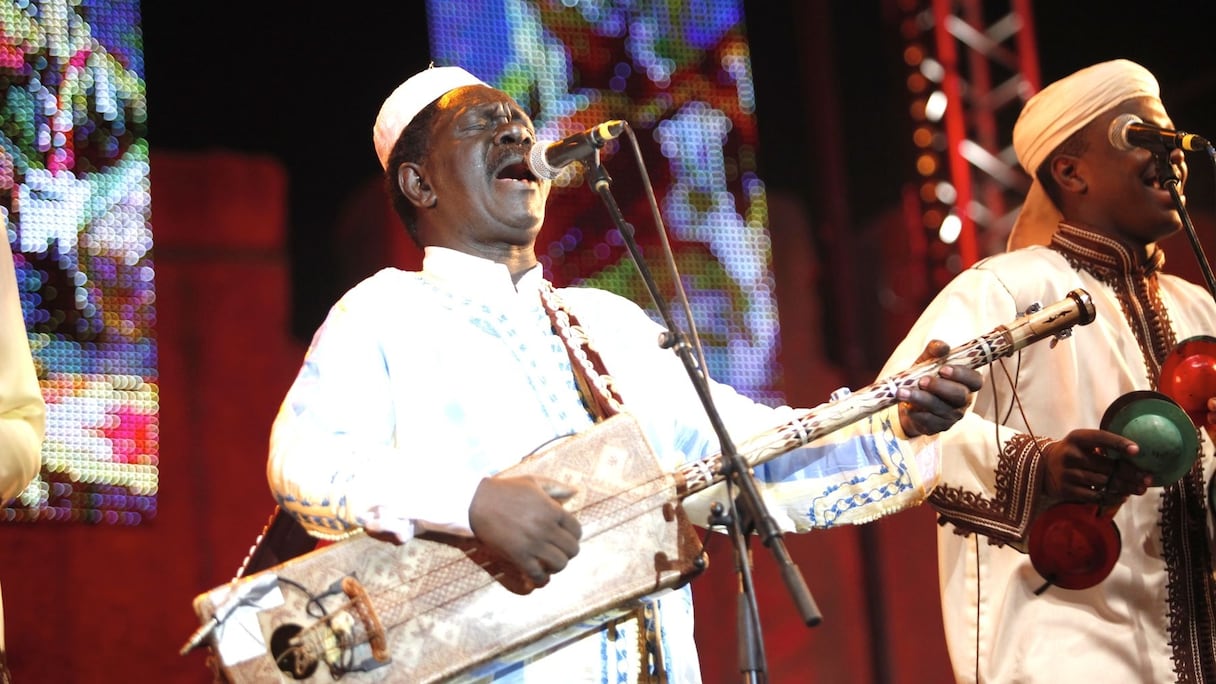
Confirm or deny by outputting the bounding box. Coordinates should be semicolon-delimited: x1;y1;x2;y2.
1051;224;1216;684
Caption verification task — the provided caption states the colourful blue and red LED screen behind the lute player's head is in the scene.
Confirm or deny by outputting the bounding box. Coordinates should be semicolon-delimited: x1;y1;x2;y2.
427;0;779;402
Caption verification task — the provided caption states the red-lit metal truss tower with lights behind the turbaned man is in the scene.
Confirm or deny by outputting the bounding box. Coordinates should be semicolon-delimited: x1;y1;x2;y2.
897;0;1040;284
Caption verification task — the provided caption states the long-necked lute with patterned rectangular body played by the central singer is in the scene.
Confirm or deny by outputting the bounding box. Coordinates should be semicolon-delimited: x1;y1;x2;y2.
195;284;1093;683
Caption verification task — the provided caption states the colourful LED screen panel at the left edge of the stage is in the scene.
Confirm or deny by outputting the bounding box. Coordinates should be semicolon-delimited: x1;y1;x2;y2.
0;0;158;525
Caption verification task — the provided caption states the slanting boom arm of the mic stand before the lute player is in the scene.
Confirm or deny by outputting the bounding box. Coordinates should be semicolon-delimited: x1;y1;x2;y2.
587;146;822;662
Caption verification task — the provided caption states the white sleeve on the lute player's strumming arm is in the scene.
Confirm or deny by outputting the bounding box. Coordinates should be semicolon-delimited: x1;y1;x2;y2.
268;295;483;540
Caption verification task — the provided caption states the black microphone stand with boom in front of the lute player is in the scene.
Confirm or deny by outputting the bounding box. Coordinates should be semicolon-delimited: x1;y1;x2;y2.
585;142;822;683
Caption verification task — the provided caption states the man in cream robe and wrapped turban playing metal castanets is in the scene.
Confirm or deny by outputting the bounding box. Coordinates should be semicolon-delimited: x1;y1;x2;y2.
884;60;1216;683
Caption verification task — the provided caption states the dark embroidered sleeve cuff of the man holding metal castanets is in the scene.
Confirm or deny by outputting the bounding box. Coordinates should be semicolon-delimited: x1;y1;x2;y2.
929;433;1051;545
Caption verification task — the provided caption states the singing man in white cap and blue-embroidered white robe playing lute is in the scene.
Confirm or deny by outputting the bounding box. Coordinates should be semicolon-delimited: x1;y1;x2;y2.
268;67;979;683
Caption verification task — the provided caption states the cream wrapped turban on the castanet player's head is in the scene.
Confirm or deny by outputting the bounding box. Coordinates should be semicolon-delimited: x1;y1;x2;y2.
1007;60;1161;250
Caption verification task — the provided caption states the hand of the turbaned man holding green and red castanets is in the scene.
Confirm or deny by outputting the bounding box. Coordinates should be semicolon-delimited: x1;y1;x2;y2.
1042;430;1153;506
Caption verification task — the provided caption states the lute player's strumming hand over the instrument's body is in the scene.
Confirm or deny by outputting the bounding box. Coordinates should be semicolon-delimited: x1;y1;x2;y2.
468;476;582;587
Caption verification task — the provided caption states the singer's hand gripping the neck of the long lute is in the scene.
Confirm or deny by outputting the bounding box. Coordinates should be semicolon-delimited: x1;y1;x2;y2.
896;340;984;437
